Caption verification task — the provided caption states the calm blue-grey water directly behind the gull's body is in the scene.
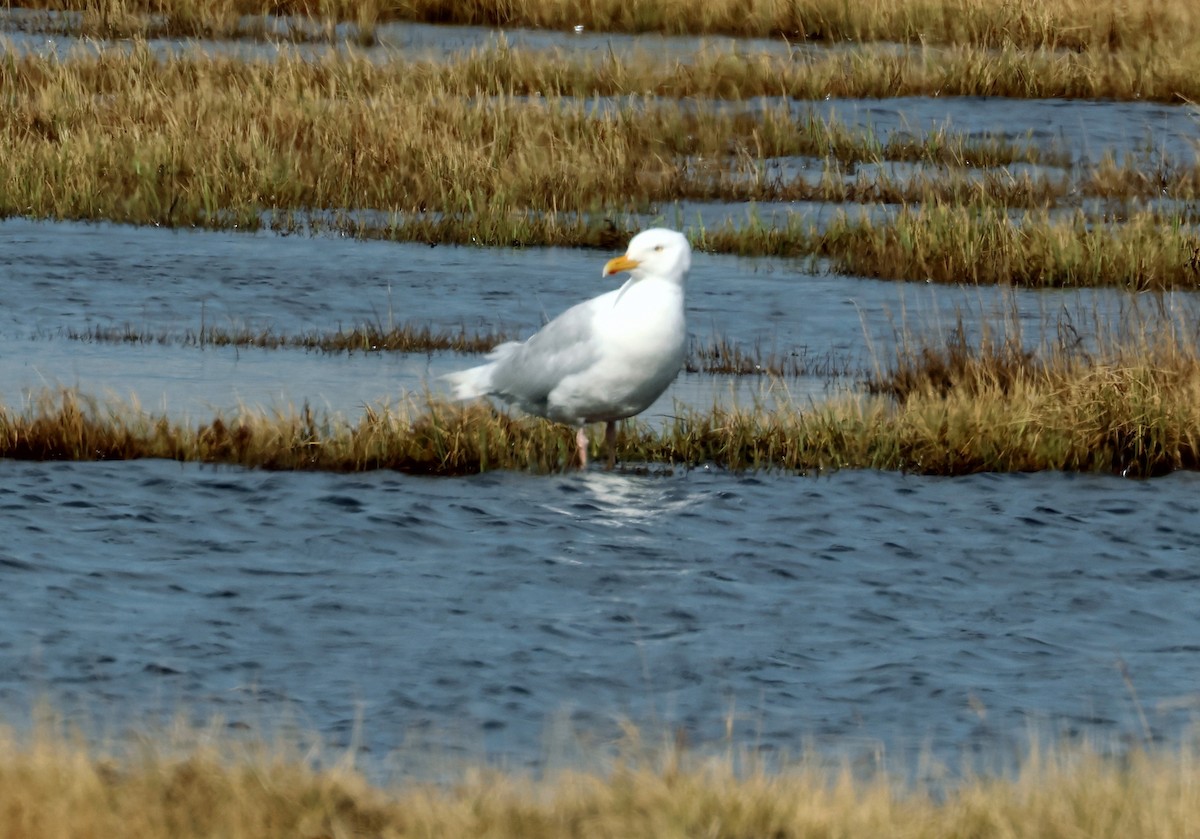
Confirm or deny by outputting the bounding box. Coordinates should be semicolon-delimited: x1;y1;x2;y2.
0;218;1161;419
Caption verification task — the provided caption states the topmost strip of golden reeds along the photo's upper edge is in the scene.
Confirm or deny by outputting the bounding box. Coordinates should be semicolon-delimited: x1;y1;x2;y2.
14;0;1200;52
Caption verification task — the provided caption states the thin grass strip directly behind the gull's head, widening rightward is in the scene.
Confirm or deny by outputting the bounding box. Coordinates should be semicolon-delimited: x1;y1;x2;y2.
271;203;1200;290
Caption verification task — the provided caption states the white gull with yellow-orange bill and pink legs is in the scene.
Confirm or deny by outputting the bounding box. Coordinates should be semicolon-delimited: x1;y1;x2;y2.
445;228;691;469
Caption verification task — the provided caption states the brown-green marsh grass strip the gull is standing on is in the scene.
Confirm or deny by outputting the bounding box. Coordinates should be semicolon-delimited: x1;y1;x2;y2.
11;295;1200;478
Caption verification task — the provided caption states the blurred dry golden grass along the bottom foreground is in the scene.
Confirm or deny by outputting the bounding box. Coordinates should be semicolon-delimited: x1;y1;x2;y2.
0;731;1200;839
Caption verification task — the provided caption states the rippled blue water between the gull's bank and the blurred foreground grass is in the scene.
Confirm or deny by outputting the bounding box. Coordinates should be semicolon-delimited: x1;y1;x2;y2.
0;461;1200;769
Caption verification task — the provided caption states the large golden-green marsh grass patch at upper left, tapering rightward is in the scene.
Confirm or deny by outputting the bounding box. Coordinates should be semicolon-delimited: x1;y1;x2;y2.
0;44;1080;227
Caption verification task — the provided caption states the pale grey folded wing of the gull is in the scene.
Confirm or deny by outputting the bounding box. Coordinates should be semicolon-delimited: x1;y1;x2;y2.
492;300;600;414
